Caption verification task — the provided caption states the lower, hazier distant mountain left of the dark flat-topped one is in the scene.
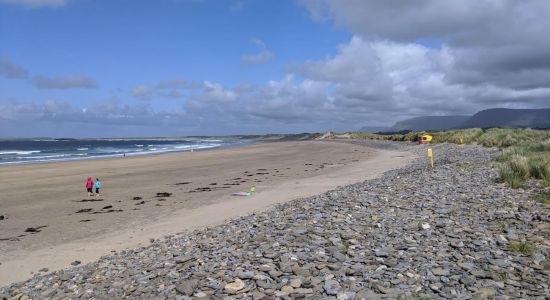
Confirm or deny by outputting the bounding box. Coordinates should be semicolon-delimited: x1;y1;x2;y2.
390;116;470;131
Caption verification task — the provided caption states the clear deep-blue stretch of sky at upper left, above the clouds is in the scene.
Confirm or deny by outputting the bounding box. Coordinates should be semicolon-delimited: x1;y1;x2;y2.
0;0;350;110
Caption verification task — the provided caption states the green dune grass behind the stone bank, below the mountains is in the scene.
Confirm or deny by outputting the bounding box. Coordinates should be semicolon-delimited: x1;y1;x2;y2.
351;128;550;188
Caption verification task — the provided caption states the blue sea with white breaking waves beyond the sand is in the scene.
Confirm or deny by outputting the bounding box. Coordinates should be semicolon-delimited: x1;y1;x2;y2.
0;138;253;165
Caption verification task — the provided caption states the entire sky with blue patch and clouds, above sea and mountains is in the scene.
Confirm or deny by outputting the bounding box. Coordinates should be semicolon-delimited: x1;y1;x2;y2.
0;0;550;137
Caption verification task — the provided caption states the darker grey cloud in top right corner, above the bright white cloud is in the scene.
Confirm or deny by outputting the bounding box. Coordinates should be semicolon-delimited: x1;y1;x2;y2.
302;0;550;88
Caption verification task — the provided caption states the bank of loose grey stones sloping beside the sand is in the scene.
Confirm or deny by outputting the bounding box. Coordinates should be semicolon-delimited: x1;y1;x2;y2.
0;141;550;299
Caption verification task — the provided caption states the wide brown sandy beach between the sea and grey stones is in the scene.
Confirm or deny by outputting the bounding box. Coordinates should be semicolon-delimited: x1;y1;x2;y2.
0;141;411;285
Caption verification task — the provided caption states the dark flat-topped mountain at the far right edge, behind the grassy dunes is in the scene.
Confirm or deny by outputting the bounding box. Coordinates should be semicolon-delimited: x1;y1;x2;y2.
460;108;550;128
